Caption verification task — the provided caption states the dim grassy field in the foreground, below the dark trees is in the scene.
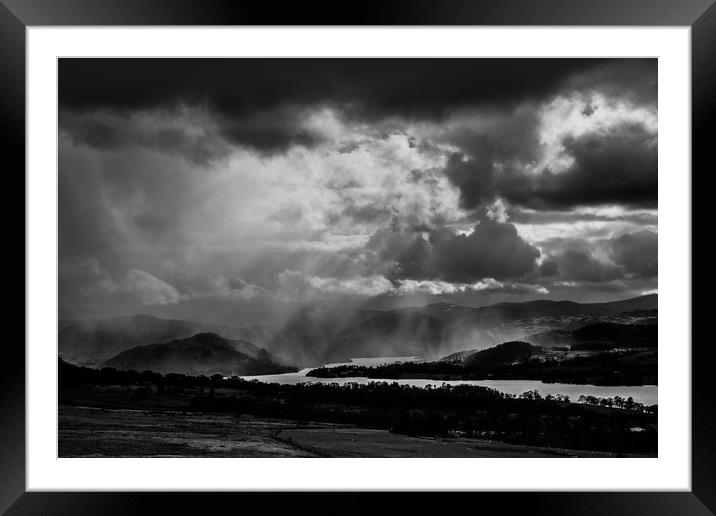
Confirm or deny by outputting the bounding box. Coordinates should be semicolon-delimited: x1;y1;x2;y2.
59;404;636;457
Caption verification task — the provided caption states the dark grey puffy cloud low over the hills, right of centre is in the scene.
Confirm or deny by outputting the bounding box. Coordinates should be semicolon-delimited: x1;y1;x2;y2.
368;220;540;283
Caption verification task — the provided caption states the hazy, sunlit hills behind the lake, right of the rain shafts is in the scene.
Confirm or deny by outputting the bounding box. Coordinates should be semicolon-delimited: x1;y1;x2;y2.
268;295;658;367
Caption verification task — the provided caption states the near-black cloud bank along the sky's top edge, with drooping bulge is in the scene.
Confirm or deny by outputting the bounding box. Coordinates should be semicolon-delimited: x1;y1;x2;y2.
59;58;655;158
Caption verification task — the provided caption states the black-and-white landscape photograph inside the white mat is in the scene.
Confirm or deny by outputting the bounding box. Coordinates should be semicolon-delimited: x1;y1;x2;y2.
58;57;666;458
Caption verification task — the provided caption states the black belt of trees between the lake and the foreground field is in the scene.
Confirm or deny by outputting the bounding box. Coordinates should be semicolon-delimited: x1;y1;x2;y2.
59;361;657;454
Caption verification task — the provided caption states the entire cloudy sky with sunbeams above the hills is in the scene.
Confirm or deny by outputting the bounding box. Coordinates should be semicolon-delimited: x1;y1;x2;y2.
59;59;657;319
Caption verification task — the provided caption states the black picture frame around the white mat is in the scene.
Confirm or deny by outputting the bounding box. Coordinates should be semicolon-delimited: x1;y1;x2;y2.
0;0;716;515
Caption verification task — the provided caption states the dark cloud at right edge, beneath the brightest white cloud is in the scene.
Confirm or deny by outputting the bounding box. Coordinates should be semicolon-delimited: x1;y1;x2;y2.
445;124;658;210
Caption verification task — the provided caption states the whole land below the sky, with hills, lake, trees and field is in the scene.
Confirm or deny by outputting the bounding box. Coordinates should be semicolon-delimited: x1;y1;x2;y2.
59;296;658;457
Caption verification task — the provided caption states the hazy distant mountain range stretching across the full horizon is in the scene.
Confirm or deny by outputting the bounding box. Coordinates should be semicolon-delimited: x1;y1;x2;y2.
59;295;658;374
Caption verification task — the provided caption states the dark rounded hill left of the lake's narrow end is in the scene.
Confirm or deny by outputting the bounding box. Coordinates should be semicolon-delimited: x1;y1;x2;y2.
103;333;296;376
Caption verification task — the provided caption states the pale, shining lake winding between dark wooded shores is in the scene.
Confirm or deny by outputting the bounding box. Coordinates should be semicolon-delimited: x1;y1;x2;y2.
242;357;658;405
